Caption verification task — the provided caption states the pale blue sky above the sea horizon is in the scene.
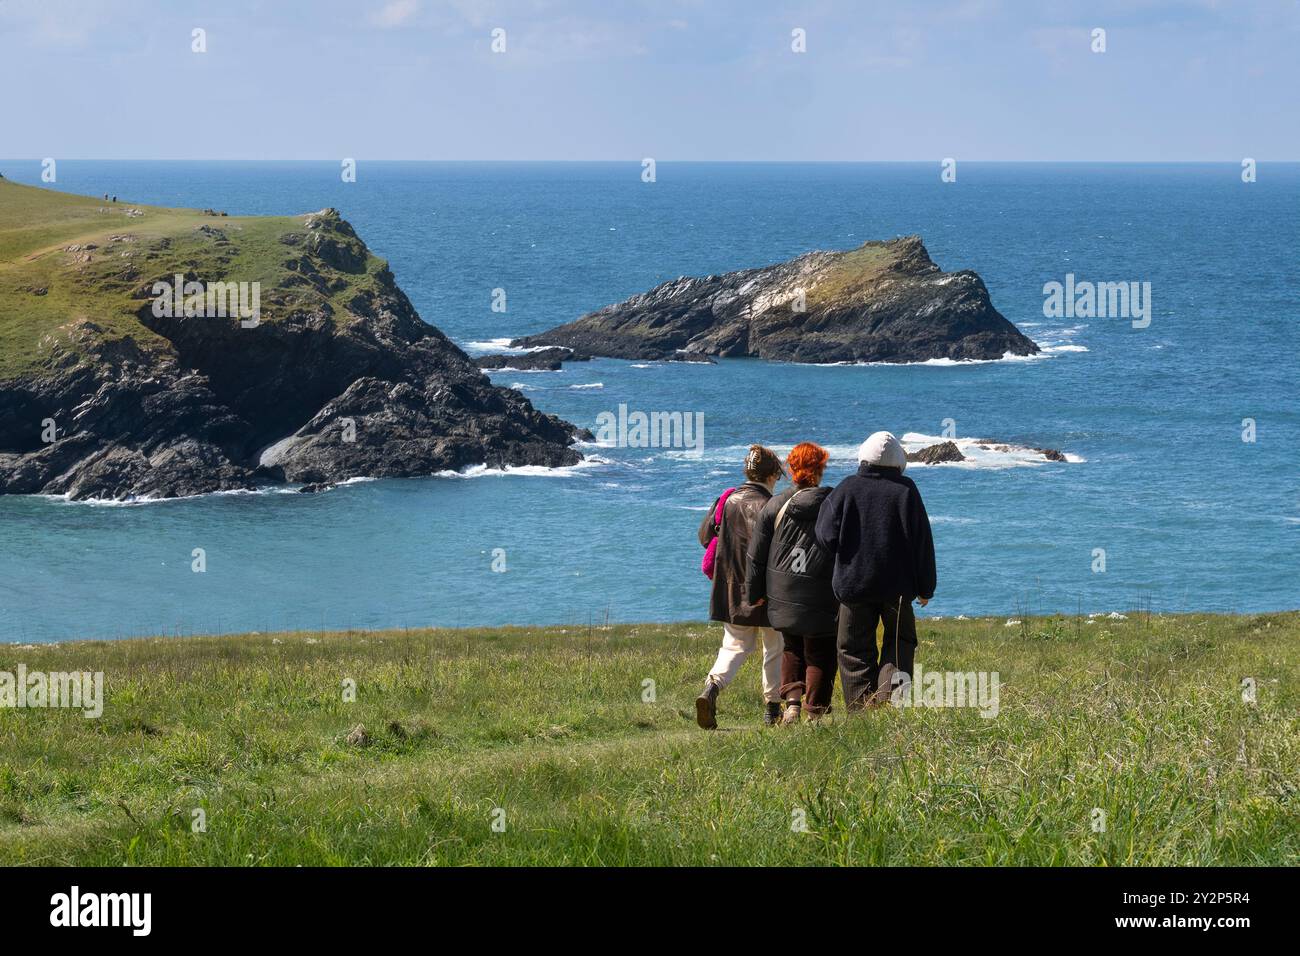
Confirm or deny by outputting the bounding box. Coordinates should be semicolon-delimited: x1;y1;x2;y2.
0;0;1300;163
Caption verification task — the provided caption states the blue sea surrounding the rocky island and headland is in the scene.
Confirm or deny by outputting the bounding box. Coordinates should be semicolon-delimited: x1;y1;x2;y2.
0;160;1300;641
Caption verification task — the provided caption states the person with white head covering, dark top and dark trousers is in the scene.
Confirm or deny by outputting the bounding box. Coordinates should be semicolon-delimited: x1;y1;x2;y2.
815;432;935;709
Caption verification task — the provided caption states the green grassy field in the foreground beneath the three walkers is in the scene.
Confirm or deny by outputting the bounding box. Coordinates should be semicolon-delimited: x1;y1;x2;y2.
0;613;1300;865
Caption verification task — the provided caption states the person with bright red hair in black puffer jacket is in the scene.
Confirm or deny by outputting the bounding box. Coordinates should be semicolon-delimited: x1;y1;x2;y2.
745;441;840;726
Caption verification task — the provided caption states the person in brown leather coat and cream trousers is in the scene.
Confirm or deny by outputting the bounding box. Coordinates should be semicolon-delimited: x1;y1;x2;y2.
696;445;784;730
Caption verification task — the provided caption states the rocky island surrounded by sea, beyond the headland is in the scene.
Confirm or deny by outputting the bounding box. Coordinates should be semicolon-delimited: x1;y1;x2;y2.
515;235;1039;362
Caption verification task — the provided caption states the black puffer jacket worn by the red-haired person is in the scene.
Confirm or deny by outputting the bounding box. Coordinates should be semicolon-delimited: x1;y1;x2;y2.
745;485;840;636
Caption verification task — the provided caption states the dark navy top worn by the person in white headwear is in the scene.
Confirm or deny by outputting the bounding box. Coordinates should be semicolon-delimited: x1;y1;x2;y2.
816;464;935;604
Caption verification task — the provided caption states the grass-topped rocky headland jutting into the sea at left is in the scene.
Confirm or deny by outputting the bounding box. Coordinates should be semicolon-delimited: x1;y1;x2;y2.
0;181;581;499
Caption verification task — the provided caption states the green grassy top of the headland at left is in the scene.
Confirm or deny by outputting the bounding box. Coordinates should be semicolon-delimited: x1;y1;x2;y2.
0;179;387;381
